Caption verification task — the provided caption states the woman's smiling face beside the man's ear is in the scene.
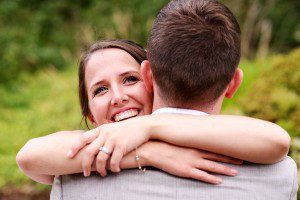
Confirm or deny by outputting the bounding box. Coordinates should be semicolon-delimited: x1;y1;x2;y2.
85;48;153;126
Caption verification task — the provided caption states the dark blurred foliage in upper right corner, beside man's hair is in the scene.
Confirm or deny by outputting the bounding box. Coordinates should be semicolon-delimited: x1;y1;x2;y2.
221;0;300;58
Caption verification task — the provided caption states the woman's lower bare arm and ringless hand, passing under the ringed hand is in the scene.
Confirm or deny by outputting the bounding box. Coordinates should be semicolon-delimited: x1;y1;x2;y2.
17;131;240;184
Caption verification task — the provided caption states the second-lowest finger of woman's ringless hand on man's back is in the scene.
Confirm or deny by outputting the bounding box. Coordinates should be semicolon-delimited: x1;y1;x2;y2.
196;160;238;176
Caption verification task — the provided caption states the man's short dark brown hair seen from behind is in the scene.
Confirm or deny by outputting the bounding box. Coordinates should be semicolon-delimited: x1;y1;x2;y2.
147;0;241;106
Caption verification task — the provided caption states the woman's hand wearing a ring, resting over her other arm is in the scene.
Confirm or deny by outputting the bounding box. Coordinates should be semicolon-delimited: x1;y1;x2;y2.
68;117;150;176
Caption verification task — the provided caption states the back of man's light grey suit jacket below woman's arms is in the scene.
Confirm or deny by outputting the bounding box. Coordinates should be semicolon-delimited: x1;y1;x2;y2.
51;157;298;200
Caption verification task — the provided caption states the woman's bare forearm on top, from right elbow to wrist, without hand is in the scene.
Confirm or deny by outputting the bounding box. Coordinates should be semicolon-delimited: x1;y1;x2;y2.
148;115;290;164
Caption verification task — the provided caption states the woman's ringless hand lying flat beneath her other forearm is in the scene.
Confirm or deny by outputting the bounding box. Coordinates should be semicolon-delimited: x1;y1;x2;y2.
139;141;242;184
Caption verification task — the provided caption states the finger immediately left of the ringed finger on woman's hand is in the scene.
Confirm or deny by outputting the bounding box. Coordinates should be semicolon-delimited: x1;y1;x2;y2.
81;137;104;176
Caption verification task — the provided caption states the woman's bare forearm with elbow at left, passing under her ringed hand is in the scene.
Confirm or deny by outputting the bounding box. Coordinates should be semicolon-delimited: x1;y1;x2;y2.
16;131;149;184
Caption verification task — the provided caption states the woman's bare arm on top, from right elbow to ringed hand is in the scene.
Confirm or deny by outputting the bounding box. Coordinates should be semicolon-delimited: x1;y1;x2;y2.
70;114;290;175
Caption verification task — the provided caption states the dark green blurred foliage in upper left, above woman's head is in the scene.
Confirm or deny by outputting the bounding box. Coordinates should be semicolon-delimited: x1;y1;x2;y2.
0;0;167;84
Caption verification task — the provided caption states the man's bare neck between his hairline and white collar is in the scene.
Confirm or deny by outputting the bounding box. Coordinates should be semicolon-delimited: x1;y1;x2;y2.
152;90;223;115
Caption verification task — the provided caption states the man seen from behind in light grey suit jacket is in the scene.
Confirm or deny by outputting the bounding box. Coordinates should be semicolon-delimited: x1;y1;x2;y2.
51;0;298;200
